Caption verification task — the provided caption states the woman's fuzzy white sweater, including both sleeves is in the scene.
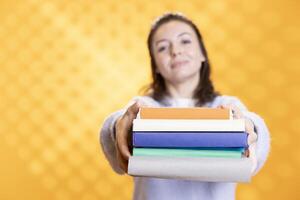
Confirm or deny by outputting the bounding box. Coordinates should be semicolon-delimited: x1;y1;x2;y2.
100;96;270;200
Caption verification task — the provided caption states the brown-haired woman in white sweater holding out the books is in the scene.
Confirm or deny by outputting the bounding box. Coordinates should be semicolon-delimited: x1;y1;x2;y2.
100;13;270;200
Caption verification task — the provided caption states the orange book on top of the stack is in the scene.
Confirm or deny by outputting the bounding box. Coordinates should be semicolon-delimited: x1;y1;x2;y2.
140;107;232;119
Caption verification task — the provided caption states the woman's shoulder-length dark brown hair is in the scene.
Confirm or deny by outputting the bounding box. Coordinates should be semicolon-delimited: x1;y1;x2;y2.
146;13;219;106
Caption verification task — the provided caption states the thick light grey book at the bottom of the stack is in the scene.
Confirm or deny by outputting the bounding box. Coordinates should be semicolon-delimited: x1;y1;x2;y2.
128;156;252;182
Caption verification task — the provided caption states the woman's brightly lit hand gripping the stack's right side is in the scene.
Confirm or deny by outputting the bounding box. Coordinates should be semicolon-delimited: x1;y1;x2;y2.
218;104;257;172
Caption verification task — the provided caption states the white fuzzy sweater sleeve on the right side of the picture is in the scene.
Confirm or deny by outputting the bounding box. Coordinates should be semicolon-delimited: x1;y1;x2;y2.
224;97;270;174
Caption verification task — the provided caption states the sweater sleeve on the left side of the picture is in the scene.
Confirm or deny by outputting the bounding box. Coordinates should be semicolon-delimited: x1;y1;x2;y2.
99;96;158;174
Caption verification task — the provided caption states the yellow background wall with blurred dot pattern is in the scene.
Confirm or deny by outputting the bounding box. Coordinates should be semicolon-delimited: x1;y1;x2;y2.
0;0;300;200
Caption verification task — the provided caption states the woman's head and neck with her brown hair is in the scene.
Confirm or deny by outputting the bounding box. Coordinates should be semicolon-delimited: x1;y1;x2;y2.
148;14;218;106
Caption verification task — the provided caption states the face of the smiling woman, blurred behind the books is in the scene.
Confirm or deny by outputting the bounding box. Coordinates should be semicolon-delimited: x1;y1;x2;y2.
152;20;205;84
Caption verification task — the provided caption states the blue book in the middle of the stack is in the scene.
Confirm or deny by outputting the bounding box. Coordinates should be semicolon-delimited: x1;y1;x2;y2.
133;131;248;148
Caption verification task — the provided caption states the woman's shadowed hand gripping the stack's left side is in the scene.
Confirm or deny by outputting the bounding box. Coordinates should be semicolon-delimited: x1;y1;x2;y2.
115;102;140;173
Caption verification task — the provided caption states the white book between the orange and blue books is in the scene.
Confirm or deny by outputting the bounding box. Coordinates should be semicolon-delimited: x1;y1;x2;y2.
133;119;245;132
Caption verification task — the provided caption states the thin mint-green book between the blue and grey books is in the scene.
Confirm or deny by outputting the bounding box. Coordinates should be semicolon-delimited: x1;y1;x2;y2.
133;148;243;158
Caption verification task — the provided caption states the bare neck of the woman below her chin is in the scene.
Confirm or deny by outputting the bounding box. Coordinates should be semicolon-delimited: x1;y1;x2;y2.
166;75;199;99
